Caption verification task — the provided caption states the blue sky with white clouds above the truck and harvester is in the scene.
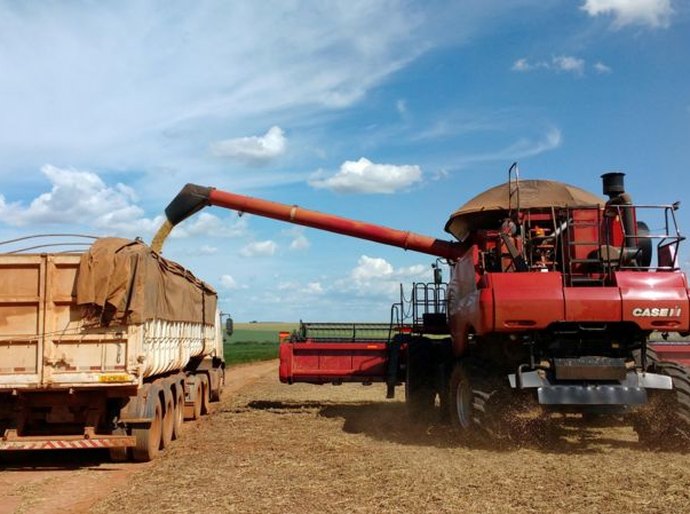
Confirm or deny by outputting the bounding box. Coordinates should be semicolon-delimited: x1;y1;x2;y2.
0;0;690;321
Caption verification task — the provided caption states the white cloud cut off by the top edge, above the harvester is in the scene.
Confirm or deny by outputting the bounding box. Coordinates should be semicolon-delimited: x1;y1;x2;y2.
581;0;673;29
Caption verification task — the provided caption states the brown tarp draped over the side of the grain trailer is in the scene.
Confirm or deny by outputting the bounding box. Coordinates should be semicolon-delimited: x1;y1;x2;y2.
77;237;217;325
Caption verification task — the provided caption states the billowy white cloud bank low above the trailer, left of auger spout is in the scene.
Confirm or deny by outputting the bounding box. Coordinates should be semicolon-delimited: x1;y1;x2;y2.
0;164;163;236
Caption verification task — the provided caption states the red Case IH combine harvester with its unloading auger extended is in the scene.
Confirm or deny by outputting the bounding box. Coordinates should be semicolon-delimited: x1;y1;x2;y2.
165;165;690;444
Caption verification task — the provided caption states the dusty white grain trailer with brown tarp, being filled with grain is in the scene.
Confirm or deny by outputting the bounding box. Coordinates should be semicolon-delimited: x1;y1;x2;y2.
0;238;224;461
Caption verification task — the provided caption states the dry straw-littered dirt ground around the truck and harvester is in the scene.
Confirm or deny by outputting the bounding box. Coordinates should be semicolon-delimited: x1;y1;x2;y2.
0;362;690;514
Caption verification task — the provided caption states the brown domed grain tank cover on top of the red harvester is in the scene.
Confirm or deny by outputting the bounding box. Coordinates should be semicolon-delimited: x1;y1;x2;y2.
445;180;605;241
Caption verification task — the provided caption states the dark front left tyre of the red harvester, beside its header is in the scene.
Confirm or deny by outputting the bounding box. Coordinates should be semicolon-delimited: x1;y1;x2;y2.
405;337;436;422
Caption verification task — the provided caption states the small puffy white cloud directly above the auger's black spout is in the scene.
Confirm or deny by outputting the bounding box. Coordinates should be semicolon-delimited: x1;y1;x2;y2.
211;126;287;164
